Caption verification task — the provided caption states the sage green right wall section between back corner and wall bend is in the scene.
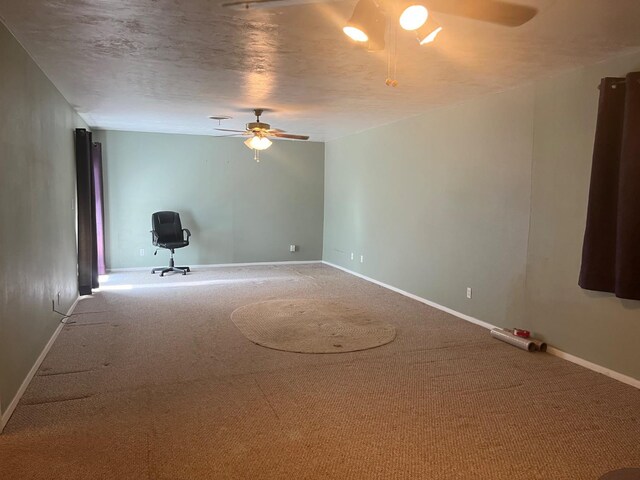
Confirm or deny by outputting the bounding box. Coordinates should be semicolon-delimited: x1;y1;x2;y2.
324;88;533;325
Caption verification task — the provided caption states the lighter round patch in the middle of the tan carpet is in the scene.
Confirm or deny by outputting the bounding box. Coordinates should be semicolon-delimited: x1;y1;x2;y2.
231;299;396;353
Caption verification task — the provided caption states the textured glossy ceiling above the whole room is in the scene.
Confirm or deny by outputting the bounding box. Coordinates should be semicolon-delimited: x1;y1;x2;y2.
0;0;640;141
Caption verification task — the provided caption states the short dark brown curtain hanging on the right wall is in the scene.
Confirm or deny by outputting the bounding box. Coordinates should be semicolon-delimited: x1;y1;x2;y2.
578;72;640;300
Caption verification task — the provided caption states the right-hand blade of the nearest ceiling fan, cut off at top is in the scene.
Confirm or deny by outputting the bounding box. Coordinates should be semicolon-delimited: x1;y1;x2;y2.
426;0;538;27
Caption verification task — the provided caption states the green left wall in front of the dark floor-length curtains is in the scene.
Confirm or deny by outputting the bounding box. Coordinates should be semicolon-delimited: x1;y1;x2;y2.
0;24;86;420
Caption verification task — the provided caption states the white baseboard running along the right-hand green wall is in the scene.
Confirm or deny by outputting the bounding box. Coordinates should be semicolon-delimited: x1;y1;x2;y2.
322;260;640;389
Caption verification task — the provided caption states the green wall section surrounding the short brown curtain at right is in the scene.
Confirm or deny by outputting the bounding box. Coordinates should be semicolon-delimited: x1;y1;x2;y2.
526;53;640;379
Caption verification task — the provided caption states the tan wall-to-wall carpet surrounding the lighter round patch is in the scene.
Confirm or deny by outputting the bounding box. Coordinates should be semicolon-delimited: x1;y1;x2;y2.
0;265;640;480
